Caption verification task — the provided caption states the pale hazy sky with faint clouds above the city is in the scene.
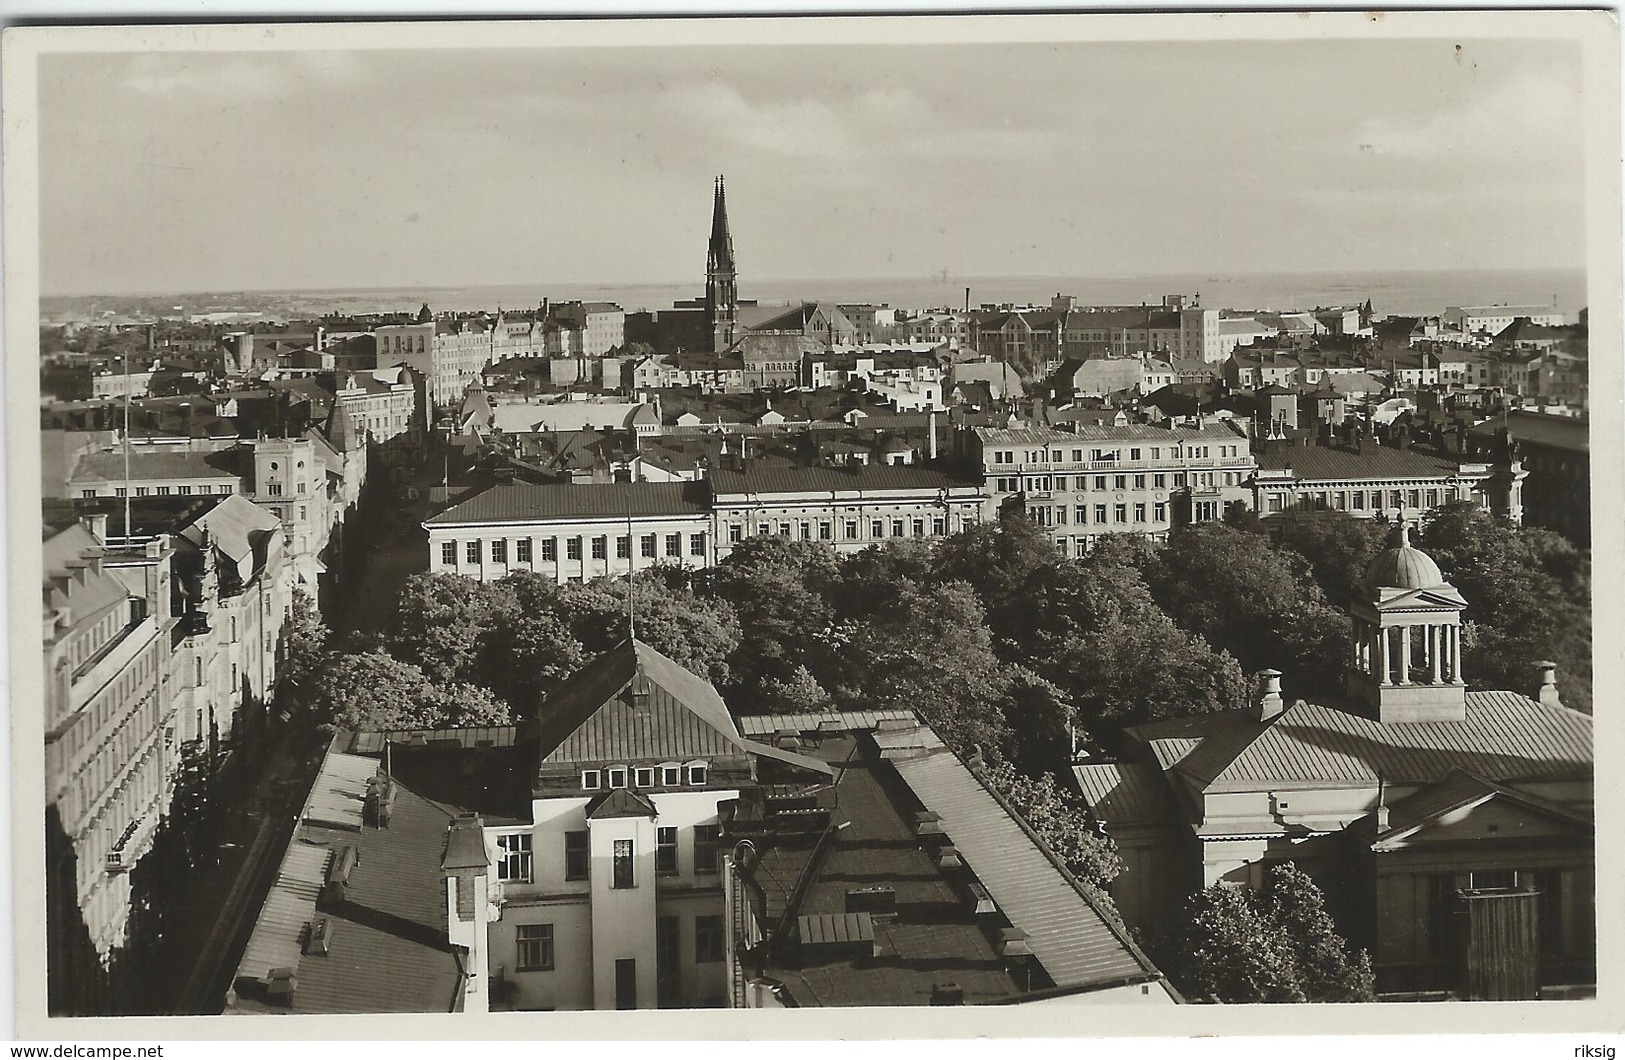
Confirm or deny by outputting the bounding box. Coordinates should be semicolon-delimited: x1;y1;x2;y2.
41;41;1584;294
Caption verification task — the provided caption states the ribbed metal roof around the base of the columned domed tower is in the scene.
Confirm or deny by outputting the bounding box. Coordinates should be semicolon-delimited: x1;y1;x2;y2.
1150;691;1593;792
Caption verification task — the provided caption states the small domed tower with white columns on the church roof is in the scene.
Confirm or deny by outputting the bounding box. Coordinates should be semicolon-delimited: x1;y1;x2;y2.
1349;523;1467;725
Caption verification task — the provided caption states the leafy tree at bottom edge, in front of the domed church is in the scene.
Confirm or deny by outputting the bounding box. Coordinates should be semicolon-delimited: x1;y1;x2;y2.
1164;862;1376;1005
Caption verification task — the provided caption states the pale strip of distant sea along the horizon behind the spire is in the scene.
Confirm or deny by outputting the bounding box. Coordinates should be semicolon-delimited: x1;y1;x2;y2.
41;268;1588;319
